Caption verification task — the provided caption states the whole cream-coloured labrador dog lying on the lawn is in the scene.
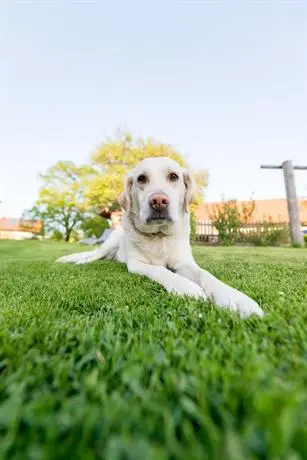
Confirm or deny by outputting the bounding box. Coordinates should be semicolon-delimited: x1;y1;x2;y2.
58;157;263;317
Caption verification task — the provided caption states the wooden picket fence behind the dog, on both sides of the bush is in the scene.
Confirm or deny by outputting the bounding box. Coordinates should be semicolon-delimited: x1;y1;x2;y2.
196;220;289;244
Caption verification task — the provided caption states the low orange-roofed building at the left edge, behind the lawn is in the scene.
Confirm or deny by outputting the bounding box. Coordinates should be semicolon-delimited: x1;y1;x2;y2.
0;217;43;240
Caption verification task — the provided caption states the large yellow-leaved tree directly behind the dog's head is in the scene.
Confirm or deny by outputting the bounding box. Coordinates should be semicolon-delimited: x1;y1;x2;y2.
86;132;208;209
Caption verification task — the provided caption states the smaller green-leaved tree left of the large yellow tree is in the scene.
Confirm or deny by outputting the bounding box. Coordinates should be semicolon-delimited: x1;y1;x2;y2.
32;161;95;241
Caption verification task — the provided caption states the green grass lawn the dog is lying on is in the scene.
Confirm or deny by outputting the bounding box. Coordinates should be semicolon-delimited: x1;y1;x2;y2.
0;241;307;460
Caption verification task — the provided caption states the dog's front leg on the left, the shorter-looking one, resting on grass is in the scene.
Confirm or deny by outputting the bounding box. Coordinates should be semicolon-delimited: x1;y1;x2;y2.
127;260;206;298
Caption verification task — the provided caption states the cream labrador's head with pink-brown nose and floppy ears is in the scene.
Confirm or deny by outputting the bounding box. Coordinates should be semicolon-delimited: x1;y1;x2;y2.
118;157;195;232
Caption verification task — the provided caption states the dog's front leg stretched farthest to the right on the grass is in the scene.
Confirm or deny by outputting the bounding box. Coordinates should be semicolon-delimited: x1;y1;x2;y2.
175;261;264;317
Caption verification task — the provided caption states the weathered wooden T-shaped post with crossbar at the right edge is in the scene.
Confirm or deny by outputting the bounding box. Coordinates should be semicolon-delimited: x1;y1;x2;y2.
261;160;307;246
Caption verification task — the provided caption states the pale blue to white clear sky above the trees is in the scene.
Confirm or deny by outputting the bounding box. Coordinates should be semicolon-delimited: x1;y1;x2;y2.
0;0;307;217
